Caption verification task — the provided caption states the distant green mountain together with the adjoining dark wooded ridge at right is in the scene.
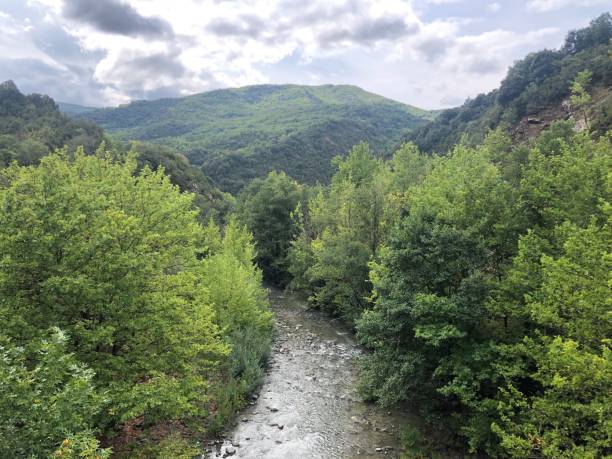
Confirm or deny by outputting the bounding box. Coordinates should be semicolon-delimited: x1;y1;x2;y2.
46;13;612;193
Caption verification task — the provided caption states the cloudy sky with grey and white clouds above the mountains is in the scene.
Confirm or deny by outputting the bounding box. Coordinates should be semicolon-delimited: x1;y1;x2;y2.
0;0;612;108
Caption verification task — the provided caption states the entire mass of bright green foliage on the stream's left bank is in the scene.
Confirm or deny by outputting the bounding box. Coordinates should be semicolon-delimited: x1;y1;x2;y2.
0;150;271;457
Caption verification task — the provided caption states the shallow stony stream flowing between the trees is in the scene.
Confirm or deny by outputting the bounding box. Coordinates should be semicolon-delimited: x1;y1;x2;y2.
208;291;402;459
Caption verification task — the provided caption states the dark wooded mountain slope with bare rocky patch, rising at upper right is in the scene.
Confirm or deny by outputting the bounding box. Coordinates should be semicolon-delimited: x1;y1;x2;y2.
404;13;612;153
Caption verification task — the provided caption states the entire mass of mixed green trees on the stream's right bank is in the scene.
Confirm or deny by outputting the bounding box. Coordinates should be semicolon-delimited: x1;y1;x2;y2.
278;122;612;458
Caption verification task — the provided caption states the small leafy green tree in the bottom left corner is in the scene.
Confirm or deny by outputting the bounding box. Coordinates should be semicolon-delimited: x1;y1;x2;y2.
0;329;109;459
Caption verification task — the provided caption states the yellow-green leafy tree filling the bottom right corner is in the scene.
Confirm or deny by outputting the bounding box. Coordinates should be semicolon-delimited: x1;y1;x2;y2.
493;217;612;458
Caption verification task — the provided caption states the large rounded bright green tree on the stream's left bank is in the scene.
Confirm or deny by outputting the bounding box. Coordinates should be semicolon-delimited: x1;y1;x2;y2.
0;150;228;427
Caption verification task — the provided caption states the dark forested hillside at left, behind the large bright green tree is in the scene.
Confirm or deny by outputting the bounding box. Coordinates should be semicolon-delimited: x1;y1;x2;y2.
0;81;233;220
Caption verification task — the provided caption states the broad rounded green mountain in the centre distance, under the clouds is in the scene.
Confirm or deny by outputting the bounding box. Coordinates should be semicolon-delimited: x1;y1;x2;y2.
80;85;435;192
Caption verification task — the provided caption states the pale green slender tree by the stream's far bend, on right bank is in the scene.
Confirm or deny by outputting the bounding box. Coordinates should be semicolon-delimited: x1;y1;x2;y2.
290;143;431;323
